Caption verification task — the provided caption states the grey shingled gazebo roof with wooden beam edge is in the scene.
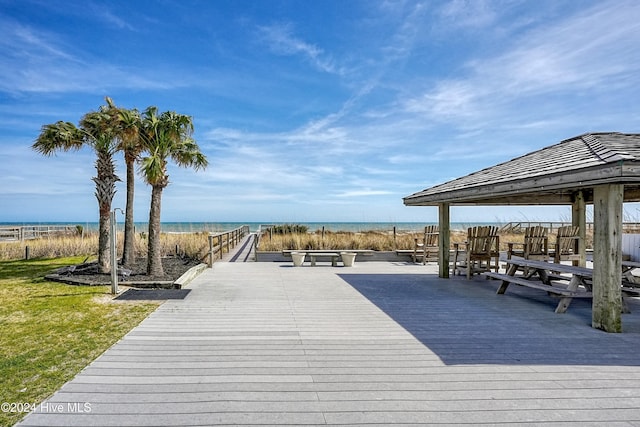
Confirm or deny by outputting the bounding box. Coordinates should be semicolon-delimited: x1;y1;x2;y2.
403;132;640;206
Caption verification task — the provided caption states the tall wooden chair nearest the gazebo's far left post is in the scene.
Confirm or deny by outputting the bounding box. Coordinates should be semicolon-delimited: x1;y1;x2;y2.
453;226;500;279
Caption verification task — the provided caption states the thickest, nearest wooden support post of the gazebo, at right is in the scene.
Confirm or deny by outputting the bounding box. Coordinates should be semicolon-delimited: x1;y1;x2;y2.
591;184;624;332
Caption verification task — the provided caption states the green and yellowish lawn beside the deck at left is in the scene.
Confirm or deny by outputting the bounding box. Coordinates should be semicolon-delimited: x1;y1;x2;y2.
0;257;158;426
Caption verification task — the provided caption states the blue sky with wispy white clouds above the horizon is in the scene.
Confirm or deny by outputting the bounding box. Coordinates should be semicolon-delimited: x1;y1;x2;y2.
0;0;640;226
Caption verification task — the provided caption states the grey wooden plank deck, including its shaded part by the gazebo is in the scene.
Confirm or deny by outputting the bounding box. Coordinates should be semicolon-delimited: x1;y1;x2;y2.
15;262;640;426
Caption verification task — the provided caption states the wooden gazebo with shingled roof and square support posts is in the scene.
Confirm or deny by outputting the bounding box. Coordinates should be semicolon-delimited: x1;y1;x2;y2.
403;132;640;332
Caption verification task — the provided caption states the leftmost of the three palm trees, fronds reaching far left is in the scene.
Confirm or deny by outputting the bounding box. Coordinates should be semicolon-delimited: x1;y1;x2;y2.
32;102;120;273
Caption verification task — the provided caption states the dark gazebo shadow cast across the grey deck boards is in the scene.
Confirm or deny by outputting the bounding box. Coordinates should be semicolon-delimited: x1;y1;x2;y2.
340;274;640;366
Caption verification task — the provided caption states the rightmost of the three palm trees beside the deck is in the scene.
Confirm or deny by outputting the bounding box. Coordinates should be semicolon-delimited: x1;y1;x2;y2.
140;107;208;276
